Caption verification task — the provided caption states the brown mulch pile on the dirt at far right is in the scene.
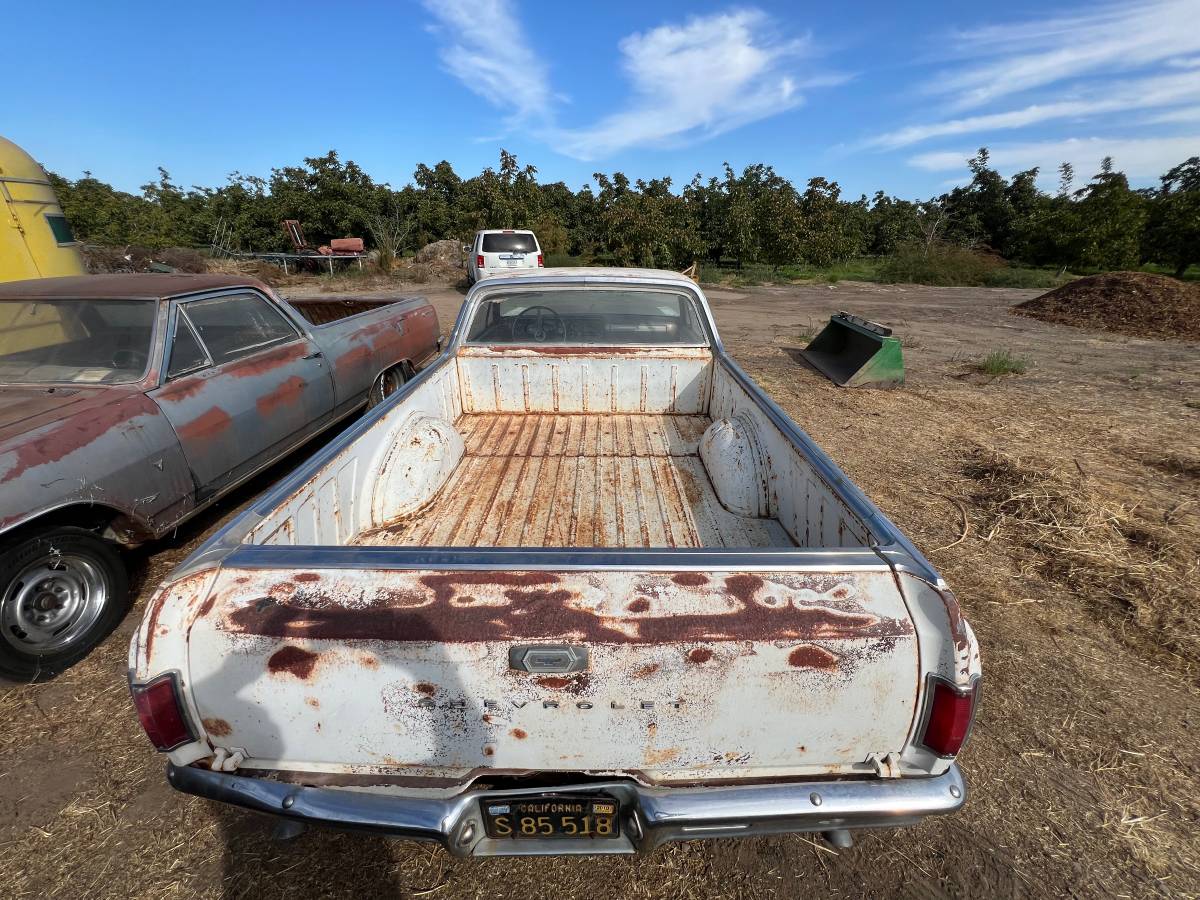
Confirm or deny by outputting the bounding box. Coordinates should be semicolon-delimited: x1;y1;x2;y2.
1013;272;1200;341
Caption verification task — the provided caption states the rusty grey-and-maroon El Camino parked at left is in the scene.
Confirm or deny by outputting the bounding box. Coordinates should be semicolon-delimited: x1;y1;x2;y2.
0;275;440;680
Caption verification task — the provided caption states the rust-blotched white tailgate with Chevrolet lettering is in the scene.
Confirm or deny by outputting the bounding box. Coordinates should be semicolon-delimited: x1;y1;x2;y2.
188;568;920;781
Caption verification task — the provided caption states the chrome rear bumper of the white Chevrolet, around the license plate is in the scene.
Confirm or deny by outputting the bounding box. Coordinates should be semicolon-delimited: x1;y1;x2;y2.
167;764;966;857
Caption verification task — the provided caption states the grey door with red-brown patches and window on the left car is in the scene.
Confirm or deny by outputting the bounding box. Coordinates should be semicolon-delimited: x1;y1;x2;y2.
150;290;334;499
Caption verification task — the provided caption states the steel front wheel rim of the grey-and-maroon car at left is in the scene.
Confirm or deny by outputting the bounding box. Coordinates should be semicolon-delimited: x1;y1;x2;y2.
0;553;108;654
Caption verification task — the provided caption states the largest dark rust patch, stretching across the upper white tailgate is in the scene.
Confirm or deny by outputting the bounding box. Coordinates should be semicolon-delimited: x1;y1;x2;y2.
223;571;912;648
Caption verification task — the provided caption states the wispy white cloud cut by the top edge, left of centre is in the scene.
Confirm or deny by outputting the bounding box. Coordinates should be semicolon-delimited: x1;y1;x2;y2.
424;0;554;124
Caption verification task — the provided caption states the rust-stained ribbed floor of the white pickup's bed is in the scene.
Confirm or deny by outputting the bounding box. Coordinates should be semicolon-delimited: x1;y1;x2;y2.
358;413;792;547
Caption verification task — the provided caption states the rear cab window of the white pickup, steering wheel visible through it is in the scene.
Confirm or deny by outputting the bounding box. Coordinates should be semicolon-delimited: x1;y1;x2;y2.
467;288;708;347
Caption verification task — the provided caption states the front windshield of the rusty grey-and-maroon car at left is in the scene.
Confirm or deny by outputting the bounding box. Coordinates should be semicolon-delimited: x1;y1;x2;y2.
0;300;157;384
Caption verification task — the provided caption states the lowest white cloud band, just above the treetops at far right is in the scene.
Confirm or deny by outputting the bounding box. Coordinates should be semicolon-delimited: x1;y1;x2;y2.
908;134;1200;181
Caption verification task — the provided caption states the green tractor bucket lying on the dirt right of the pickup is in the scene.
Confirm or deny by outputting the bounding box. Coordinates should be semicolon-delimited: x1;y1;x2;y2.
800;312;904;388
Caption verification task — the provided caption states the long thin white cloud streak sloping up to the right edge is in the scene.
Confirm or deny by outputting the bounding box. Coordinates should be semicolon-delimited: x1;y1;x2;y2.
865;72;1200;149
